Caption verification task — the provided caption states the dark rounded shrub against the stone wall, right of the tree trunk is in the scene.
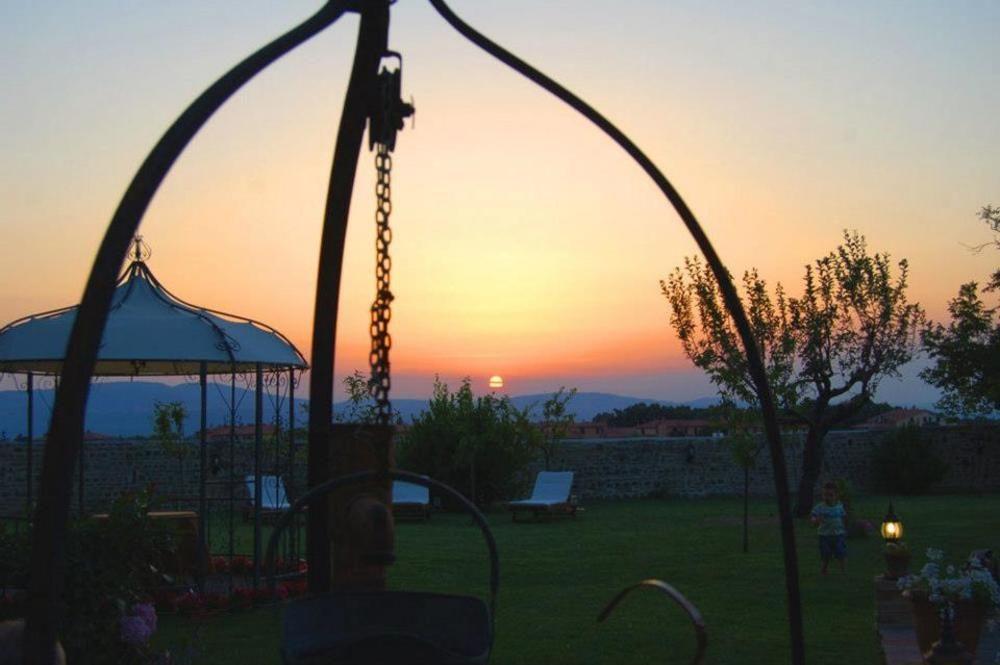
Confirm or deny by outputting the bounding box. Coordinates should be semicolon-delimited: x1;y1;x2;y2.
873;426;948;494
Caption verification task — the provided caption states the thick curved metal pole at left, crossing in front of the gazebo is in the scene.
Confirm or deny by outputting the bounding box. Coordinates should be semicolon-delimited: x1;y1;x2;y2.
25;5;347;663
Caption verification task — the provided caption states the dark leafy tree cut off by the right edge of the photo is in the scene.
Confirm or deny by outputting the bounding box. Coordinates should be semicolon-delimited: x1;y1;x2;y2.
920;206;1000;416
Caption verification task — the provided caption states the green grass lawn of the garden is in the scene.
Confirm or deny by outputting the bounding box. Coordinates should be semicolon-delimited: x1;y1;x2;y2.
156;495;1000;665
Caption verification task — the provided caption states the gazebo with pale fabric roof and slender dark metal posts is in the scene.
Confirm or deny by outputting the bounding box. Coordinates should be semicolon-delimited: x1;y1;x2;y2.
0;237;307;580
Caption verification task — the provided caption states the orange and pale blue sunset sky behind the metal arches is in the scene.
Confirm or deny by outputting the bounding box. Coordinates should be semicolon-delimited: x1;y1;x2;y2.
0;0;1000;402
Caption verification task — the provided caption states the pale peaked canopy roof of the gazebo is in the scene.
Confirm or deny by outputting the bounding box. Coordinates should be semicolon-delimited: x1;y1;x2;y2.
0;246;307;376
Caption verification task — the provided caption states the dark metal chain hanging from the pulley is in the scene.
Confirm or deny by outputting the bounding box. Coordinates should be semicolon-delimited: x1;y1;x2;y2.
368;143;392;425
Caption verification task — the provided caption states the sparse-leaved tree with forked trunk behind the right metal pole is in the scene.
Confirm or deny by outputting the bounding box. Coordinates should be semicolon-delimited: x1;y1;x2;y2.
660;231;924;517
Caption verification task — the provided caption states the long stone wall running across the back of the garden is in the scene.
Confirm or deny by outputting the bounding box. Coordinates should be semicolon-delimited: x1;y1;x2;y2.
0;425;1000;515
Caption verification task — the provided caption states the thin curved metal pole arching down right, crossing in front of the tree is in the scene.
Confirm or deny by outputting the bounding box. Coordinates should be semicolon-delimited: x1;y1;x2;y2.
429;0;805;665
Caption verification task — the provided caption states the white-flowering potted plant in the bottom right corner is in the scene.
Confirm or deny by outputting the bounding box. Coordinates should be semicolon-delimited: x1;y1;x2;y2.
898;548;1000;654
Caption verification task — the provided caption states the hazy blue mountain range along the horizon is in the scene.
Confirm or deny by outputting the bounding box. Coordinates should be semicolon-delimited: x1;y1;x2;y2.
0;381;718;439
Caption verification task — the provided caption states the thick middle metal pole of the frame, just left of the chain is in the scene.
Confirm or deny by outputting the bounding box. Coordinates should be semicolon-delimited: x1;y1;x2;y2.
306;0;389;593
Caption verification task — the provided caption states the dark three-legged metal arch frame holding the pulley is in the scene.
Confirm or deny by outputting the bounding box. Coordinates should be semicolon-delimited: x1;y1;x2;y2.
25;0;804;665
